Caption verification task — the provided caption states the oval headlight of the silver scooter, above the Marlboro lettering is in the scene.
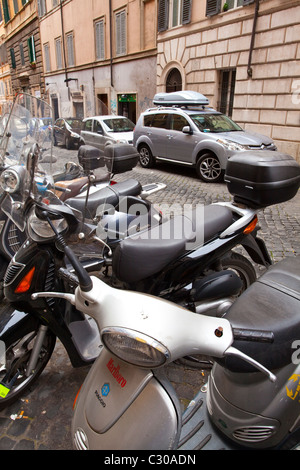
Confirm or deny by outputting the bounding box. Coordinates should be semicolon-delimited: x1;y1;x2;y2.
101;328;170;368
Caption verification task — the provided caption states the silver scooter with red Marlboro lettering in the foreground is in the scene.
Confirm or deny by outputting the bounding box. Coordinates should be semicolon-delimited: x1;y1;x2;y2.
33;241;300;450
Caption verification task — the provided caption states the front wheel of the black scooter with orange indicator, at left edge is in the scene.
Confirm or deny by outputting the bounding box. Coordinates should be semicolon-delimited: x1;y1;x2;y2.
0;327;56;411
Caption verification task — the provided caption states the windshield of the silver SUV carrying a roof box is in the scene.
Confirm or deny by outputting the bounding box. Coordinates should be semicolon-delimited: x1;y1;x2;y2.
190;113;243;132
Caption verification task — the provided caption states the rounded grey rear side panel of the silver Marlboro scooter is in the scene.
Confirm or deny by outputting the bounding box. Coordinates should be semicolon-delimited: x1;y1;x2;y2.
208;364;300;449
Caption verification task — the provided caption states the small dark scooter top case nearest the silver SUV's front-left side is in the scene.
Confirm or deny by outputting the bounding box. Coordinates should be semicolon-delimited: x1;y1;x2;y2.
104;144;139;175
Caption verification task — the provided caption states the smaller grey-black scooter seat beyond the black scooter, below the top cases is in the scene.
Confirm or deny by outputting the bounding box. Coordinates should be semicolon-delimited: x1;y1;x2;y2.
66;179;142;219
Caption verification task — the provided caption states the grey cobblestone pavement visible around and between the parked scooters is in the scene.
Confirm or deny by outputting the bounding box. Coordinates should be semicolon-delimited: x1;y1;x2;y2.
0;154;300;450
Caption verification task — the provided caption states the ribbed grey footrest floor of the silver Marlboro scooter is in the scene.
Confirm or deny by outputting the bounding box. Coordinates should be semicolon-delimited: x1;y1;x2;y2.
178;392;234;450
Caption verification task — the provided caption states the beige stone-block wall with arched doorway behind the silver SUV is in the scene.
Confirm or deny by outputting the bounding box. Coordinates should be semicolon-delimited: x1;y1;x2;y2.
157;0;300;162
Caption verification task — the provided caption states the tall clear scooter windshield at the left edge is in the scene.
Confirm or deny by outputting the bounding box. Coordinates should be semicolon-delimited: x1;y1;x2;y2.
0;93;53;230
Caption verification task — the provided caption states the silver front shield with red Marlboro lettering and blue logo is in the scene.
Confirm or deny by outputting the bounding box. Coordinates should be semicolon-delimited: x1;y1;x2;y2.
72;349;181;450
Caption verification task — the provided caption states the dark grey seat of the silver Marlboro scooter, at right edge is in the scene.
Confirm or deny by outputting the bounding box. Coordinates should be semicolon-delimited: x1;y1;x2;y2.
221;256;300;372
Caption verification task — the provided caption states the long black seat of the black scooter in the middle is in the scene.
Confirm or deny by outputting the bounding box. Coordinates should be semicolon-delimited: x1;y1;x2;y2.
113;205;232;283
